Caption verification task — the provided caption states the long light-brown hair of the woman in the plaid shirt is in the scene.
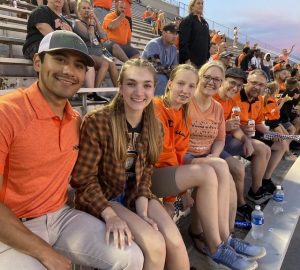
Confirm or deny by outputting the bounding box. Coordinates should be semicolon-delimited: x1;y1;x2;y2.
107;58;162;164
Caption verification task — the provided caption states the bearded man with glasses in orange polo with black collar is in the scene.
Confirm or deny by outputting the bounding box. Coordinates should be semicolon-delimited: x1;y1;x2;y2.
234;69;287;202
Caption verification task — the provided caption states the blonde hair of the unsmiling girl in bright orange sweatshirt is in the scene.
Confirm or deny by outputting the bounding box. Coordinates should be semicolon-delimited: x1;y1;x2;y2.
162;64;199;126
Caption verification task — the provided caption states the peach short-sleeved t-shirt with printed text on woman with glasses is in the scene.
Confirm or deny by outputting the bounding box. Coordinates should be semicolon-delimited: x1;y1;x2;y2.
188;97;226;156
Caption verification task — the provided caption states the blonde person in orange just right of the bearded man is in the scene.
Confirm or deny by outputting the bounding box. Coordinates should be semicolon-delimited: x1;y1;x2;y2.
263;82;297;161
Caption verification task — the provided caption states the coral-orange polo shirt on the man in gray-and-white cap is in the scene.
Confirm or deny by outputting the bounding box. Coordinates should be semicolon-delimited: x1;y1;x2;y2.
0;82;80;218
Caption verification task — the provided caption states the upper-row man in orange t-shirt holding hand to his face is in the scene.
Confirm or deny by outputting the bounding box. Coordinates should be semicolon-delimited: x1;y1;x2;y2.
102;1;140;62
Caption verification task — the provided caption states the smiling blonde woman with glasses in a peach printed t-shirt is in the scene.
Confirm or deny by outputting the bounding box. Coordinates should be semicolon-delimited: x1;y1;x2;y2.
185;61;266;269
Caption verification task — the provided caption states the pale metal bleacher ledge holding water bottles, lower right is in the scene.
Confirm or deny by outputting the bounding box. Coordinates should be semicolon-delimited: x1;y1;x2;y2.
245;158;300;270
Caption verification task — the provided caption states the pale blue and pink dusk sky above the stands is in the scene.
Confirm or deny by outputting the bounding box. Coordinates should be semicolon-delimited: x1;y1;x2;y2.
179;0;300;59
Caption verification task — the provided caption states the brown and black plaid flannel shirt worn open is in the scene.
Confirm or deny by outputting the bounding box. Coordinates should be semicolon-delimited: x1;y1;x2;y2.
71;107;163;217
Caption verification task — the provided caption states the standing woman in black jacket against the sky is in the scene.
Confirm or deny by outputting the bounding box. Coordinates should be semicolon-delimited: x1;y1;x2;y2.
179;0;210;68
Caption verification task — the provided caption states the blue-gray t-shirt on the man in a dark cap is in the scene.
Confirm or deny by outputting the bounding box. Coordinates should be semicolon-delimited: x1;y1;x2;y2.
142;37;178;68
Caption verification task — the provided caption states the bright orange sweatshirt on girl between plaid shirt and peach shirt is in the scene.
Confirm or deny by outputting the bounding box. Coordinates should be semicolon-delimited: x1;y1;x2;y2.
154;97;191;168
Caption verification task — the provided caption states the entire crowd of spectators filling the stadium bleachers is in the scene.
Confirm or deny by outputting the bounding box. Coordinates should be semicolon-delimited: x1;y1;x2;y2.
0;0;300;270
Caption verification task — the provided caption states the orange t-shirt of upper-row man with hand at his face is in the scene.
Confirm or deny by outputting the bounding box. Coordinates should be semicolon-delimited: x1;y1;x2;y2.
102;12;131;45
